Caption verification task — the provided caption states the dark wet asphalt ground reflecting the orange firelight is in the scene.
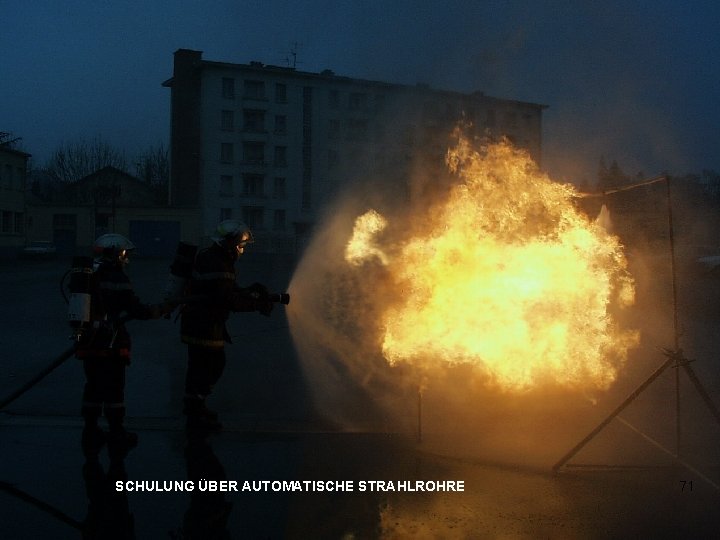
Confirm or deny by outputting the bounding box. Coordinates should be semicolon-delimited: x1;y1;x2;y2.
0;258;720;539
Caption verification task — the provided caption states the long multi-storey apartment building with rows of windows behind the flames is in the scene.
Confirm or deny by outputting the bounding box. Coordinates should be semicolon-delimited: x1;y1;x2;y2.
163;49;545;252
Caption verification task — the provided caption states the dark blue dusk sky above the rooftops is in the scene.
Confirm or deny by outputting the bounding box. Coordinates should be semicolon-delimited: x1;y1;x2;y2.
0;0;720;185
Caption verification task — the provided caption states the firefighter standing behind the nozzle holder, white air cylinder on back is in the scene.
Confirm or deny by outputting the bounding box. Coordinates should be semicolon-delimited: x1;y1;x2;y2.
75;234;165;454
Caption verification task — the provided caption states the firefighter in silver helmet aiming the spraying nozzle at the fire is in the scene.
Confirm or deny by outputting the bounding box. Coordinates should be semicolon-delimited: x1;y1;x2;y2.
180;220;273;431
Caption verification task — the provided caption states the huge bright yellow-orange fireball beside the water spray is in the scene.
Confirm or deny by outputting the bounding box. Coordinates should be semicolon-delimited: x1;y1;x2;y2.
346;133;638;390
